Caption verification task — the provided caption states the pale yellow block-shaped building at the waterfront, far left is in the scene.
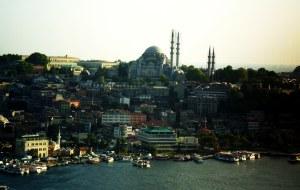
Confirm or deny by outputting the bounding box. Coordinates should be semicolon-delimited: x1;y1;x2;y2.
16;134;49;158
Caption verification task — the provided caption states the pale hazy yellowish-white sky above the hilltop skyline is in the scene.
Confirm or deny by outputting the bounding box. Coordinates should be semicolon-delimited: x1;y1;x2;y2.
0;0;300;71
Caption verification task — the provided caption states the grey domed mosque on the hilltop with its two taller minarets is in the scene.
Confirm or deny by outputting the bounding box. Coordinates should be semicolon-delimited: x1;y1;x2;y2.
129;31;184;80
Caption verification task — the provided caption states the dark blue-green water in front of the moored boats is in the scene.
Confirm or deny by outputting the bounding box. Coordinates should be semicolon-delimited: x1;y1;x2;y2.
0;157;300;190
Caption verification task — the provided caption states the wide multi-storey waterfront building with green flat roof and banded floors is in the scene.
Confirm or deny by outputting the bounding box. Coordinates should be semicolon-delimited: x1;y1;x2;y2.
138;126;177;151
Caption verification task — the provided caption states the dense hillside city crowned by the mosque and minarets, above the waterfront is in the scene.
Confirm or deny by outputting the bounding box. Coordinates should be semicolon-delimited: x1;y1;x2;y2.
0;35;300;162
